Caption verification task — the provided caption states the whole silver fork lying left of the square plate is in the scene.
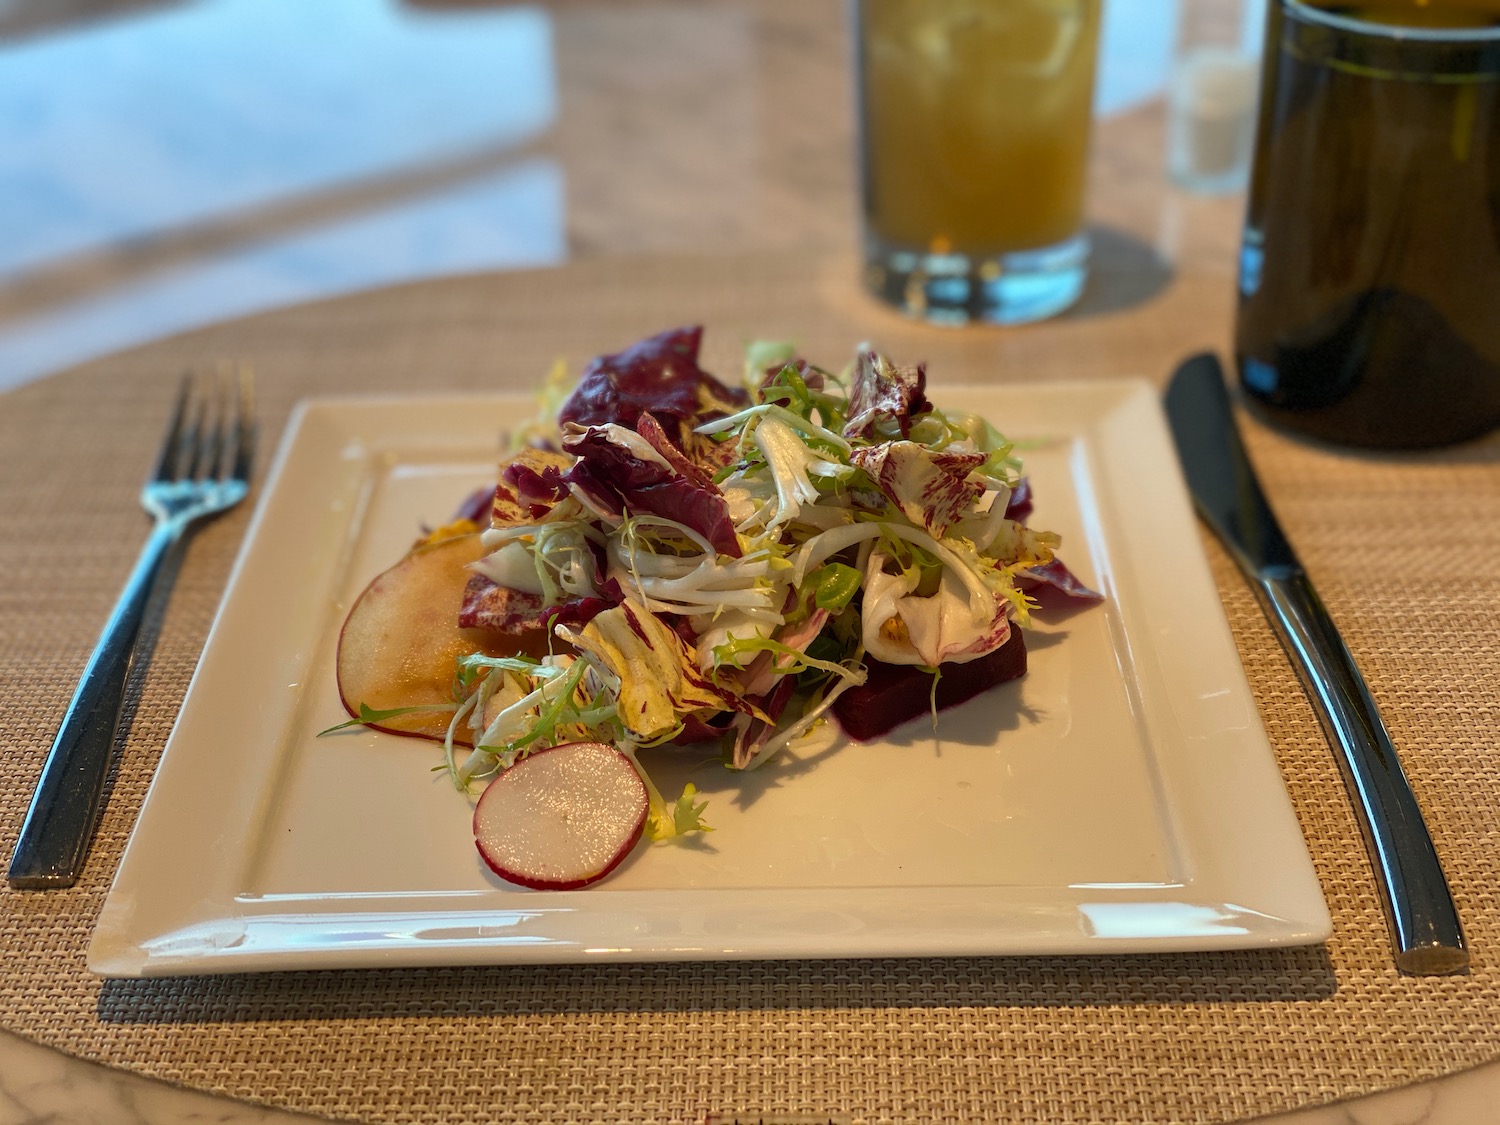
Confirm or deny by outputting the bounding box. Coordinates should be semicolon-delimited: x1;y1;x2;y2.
8;369;255;890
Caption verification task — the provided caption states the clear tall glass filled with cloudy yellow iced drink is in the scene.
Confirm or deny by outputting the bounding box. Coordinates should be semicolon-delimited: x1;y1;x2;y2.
855;0;1101;324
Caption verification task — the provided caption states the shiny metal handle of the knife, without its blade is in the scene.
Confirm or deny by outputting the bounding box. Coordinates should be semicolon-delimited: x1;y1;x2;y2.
1256;570;1469;977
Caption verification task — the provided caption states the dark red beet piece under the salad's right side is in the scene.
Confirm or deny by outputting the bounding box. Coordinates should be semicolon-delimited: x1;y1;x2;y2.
833;626;1026;743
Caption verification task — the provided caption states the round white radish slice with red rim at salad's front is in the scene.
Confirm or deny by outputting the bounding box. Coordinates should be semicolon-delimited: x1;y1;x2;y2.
474;743;651;891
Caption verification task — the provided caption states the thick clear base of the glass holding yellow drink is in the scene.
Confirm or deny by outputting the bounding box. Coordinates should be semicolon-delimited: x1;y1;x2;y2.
864;234;1089;324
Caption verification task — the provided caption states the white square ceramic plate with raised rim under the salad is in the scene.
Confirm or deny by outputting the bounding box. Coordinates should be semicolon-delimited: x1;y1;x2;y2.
89;380;1331;977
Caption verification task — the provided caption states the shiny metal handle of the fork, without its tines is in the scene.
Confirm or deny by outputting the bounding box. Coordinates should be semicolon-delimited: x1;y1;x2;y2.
8;519;185;890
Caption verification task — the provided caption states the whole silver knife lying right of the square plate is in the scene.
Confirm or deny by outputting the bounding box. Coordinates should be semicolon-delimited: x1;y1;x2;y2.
1166;354;1469;977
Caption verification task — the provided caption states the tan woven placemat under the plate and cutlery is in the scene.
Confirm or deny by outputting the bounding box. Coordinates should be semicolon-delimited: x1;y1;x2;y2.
0;257;1500;1125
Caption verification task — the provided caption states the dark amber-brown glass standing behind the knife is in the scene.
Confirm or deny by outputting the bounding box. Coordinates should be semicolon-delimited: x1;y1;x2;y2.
1236;0;1500;449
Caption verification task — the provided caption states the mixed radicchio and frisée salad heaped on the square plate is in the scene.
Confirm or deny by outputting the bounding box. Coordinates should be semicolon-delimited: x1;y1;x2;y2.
330;327;1100;888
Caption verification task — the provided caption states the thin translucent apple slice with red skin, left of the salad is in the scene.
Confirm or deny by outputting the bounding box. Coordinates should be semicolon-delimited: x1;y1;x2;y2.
338;534;546;746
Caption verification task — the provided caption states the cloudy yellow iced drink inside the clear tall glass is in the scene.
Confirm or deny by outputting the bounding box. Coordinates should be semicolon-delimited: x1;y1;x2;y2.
858;0;1100;258
